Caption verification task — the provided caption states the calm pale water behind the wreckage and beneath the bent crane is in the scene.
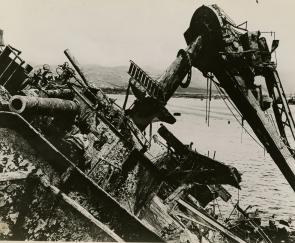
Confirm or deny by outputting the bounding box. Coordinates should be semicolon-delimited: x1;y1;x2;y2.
111;95;295;224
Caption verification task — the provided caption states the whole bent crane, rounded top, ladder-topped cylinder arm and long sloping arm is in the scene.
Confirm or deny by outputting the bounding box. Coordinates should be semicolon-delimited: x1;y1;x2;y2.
129;5;295;191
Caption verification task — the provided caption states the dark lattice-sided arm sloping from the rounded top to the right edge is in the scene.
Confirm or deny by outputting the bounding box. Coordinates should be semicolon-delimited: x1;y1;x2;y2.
185;5;295;191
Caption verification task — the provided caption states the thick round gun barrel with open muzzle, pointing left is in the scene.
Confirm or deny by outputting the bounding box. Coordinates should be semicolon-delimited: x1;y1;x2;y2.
9;95;80;116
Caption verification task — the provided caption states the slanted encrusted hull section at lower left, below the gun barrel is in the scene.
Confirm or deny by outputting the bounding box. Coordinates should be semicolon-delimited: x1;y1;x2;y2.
0;112;161;241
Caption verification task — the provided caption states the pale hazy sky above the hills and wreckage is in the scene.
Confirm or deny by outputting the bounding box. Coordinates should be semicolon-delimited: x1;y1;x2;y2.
0;0;295;88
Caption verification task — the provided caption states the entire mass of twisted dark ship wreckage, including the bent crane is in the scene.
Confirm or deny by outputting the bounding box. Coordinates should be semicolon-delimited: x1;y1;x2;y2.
0;5;295;242
